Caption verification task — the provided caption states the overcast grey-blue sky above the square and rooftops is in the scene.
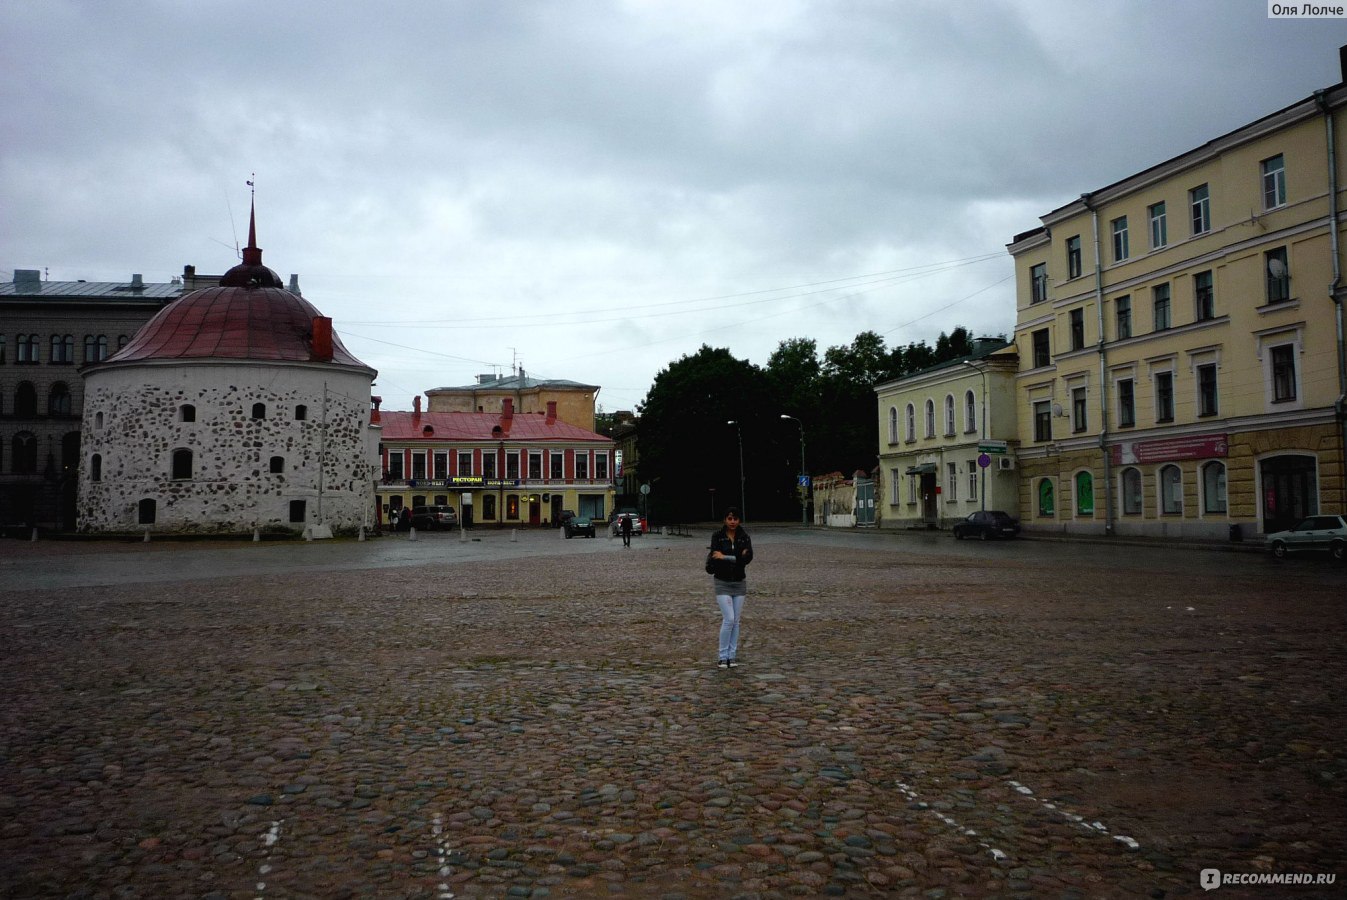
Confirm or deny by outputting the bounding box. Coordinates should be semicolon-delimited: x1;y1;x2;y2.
0;0;1347;411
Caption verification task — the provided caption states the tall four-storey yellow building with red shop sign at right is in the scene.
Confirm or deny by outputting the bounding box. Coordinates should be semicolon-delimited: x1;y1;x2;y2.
1009;70;1347;539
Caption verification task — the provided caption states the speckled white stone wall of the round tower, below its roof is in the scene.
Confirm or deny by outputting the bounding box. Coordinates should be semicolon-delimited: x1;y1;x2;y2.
79;361;377;534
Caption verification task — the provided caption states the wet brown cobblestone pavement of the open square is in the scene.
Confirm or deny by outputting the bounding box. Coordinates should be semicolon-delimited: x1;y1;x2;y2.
0;529;1347;899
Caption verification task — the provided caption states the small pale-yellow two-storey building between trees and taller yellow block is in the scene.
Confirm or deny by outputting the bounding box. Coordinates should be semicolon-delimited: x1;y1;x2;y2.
874;338;1020;528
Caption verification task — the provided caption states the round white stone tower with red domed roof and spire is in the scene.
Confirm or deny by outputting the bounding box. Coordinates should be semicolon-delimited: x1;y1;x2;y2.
78;211;379;535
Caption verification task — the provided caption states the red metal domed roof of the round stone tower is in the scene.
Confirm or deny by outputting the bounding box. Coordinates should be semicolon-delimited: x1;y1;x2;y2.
108;287;369;368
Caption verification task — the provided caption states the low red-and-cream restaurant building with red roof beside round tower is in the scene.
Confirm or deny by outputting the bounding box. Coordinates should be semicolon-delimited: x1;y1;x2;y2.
374;397;616;525
